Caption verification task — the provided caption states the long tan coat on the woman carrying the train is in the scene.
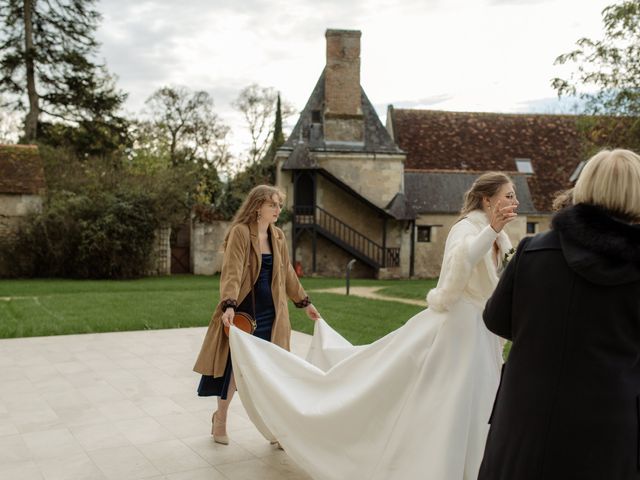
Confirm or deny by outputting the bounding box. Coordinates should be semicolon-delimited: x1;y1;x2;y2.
193;223;308;377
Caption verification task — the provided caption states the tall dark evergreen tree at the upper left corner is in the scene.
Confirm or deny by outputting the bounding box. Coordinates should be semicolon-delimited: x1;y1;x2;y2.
0;0;126;142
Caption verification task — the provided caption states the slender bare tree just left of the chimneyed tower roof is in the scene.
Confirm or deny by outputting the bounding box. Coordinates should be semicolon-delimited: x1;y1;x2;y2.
233;83;295;165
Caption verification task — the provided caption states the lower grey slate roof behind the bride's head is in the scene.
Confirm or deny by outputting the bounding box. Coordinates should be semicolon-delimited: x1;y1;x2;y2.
404;170;536;214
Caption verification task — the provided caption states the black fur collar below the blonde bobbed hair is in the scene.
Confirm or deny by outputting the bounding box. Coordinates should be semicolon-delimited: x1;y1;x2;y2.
552;203;640;265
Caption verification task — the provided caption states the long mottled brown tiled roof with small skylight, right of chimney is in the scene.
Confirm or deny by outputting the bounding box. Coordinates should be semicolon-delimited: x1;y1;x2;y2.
389;107;585;212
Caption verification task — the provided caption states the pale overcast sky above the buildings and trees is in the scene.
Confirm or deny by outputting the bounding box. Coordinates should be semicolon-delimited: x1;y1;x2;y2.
98;0;614;158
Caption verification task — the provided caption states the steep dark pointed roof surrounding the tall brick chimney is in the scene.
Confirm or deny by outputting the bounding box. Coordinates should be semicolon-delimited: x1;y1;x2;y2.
281;71;402;159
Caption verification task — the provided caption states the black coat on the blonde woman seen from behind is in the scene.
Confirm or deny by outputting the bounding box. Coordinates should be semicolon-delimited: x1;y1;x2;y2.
478;204;640;480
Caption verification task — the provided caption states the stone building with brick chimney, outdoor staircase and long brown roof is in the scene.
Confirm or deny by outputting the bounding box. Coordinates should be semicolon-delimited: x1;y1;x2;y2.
276;30;596;278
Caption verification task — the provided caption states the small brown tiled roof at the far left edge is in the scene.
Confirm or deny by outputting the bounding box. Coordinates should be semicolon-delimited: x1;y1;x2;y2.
0;145;46;195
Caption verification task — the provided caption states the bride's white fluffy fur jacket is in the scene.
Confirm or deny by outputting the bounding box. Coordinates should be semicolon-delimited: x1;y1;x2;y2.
427;210;511;312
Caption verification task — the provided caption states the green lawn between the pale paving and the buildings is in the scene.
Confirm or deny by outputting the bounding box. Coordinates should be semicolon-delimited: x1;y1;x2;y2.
0;275;433;344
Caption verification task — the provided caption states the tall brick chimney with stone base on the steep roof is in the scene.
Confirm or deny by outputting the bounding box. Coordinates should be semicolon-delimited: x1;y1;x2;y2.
323;30;364;143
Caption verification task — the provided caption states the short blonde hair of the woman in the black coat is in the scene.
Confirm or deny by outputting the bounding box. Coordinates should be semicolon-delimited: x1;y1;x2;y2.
573;149;640;221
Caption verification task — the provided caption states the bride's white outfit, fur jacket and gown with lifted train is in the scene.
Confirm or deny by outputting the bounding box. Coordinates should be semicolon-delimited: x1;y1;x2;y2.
230;211;511;480
